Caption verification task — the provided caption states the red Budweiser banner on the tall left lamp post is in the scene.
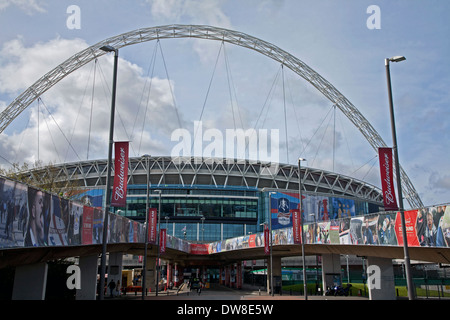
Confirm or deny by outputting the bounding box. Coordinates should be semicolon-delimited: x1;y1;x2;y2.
111;141;128;207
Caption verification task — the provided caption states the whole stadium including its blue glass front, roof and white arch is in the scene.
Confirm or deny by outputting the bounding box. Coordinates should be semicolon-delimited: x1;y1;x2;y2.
0;26;434;296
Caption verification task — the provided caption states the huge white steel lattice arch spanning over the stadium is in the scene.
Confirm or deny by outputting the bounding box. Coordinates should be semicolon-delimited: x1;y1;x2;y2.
0;25;423;208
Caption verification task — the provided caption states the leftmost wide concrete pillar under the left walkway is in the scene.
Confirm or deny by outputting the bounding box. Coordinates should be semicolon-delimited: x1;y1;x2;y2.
12;262;48;300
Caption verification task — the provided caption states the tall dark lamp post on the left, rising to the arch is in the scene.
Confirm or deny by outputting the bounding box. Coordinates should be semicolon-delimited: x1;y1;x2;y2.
99;45;119;300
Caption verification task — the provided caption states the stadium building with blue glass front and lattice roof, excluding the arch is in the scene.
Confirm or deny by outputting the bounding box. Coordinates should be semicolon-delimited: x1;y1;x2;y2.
23;156;383;242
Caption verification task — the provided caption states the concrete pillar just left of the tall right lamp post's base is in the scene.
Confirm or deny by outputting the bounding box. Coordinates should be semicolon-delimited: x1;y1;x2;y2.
367;257;397;300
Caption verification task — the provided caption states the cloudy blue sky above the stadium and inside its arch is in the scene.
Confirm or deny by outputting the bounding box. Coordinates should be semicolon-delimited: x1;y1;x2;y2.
0;0;450;205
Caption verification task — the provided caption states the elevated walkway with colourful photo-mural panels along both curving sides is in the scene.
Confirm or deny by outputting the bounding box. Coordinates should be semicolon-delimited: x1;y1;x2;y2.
0;174;450;293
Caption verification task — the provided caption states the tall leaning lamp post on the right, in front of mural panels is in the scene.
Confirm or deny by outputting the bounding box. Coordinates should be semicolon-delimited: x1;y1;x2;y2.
385;56;415;300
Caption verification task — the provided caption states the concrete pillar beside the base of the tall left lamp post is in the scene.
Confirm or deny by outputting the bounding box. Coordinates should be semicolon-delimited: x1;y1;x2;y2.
75;255;98;300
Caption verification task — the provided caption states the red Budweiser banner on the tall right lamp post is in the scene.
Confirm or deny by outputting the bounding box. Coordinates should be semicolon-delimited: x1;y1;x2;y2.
378;148;398;211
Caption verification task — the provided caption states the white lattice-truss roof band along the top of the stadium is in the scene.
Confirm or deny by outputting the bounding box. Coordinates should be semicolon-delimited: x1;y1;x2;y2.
21;156;383;204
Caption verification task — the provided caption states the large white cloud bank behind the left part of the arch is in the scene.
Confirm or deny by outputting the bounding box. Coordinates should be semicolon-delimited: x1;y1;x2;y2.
0;38;185;163
